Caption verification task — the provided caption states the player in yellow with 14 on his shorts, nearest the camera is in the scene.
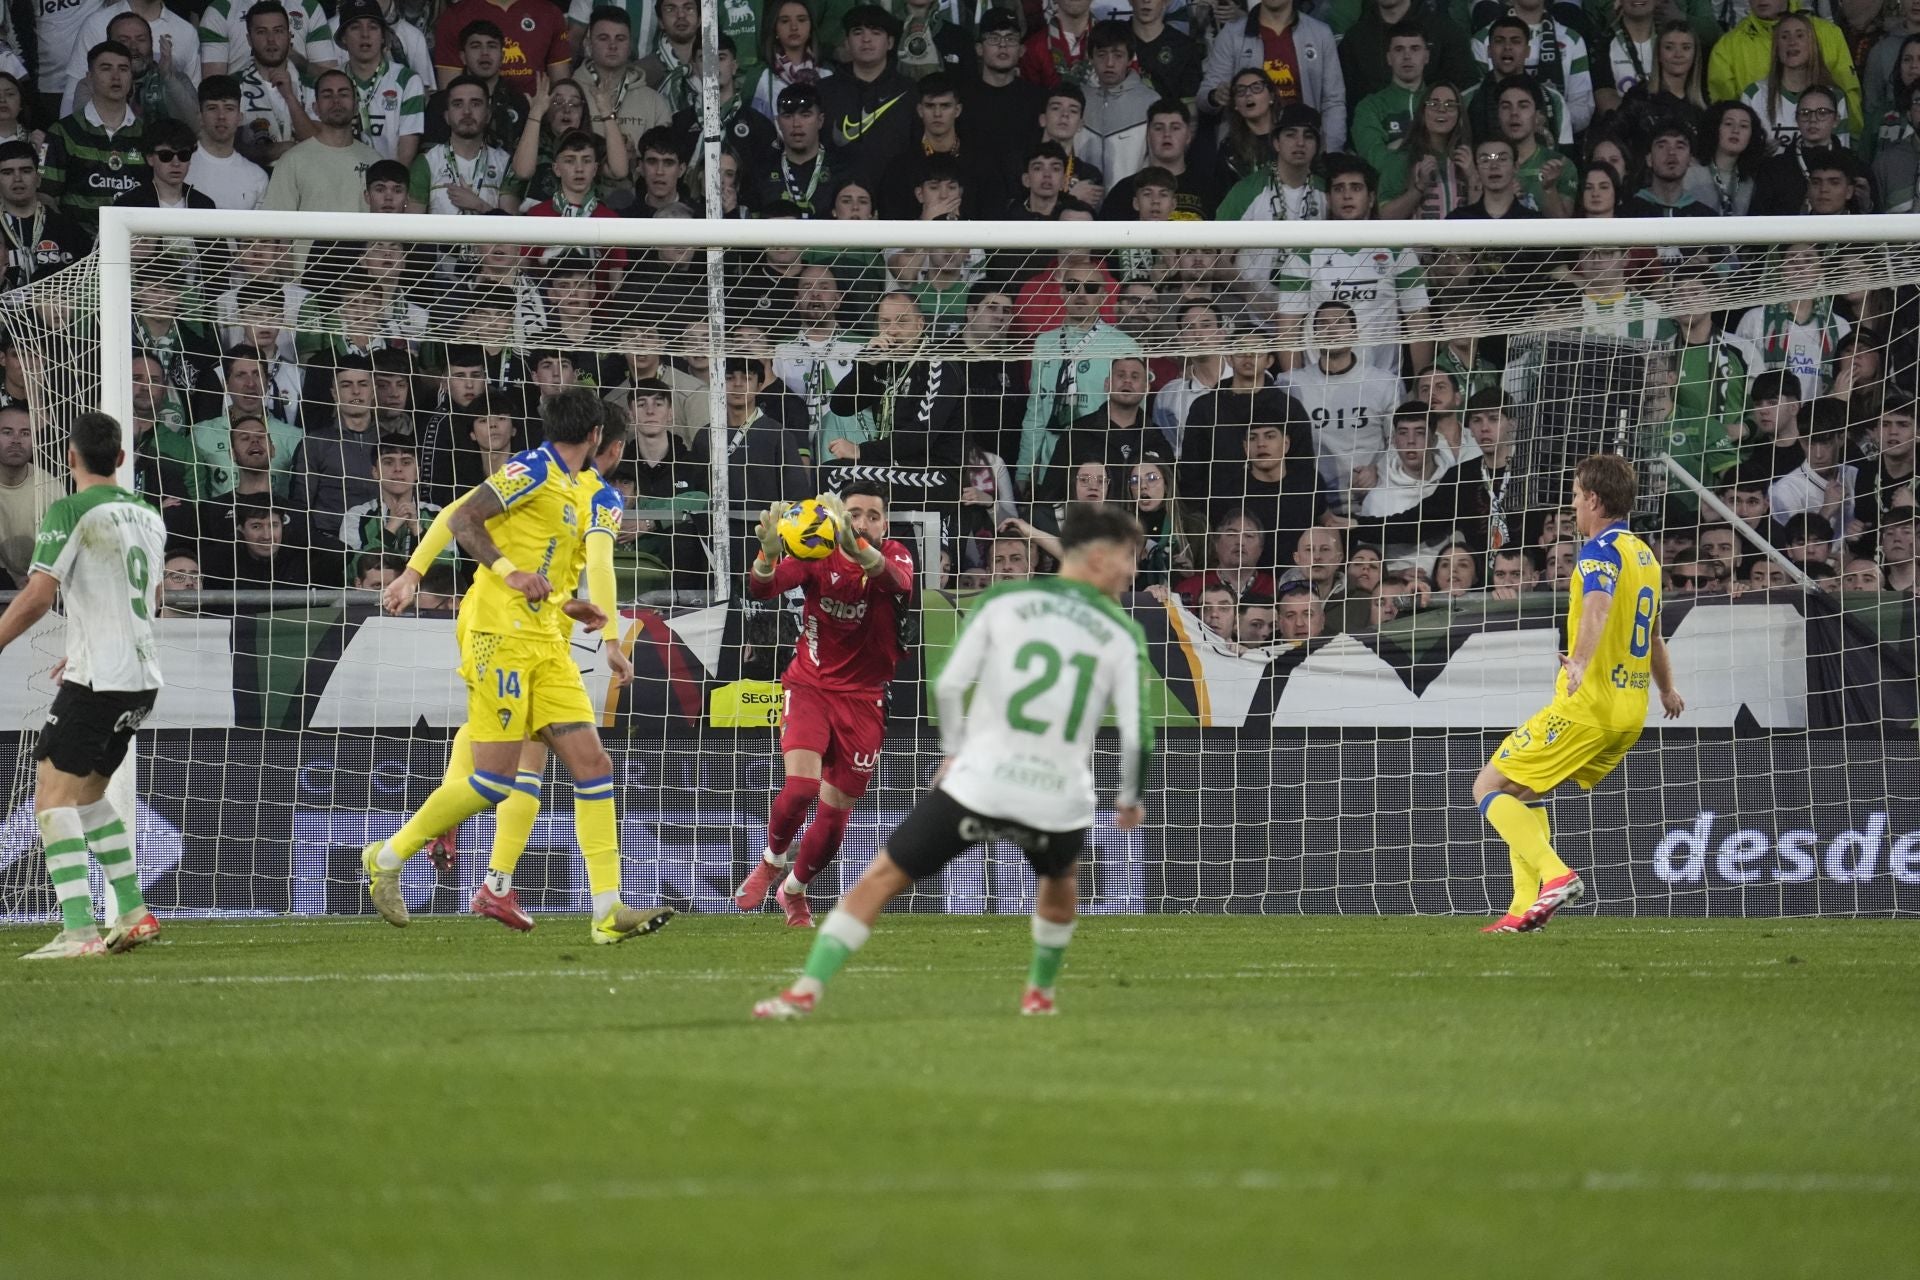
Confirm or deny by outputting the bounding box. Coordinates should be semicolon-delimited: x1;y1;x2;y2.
361;388;674;942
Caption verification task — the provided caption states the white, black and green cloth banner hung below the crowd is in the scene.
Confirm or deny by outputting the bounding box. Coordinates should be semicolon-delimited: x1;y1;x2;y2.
0;591;1920;739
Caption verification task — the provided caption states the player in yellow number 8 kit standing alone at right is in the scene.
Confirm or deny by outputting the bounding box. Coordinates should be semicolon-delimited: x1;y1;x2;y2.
1473;453;1686;933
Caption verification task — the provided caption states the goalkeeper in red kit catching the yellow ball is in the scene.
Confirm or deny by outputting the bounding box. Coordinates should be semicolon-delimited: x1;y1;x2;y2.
733;482;914;929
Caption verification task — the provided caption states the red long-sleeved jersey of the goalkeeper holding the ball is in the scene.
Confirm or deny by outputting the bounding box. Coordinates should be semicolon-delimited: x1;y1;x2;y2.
747;537;914;695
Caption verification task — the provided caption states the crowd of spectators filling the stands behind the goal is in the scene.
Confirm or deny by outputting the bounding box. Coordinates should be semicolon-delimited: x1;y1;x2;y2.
0;0;1920;649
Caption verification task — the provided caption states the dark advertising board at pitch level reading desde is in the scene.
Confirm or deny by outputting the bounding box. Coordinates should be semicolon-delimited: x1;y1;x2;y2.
0;729;1920;917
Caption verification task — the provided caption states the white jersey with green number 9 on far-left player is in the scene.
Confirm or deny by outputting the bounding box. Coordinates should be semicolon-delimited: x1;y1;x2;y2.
31;484;167;693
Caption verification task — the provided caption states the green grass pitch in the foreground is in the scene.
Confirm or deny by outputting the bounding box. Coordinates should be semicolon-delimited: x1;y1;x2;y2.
0;917;1920;1280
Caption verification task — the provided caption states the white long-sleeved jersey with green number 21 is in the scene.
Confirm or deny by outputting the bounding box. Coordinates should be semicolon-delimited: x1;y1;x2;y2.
935;578;1154;831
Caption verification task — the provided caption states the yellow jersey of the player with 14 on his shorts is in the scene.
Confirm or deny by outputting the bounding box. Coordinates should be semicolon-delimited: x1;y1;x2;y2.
461;443;603;643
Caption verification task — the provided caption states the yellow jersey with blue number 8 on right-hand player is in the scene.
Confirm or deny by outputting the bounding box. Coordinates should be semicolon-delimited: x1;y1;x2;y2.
1548;524;1661;729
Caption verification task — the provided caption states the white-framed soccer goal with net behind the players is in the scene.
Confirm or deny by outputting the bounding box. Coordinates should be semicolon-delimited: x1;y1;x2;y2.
0;209;1920;915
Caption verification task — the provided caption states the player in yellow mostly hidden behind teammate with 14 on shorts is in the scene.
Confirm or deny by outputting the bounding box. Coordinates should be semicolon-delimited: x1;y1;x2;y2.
382;420;634;933
